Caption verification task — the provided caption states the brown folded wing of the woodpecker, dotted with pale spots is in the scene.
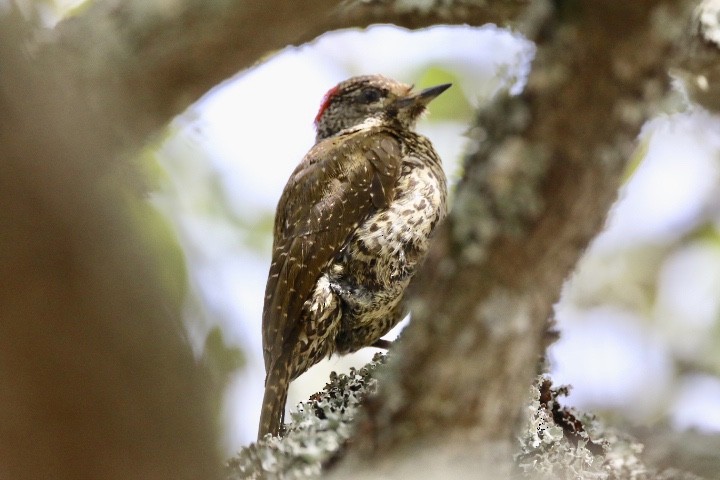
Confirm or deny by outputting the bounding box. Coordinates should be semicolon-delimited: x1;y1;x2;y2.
263;131;401;372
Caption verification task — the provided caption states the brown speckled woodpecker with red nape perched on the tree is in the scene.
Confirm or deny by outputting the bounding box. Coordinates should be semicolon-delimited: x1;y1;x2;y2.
258;75;451;440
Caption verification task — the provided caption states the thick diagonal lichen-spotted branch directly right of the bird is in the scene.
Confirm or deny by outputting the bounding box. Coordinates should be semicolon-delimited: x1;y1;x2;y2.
339;0;704;476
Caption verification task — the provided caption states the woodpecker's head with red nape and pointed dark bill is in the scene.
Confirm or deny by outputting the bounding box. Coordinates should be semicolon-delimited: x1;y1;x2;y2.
315;75;450;141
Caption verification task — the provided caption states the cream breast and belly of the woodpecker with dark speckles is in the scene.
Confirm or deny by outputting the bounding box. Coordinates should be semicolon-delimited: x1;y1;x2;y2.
330;137;447;353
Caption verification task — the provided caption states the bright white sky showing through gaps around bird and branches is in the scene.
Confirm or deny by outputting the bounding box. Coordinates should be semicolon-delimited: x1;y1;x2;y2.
152;23;720;451
